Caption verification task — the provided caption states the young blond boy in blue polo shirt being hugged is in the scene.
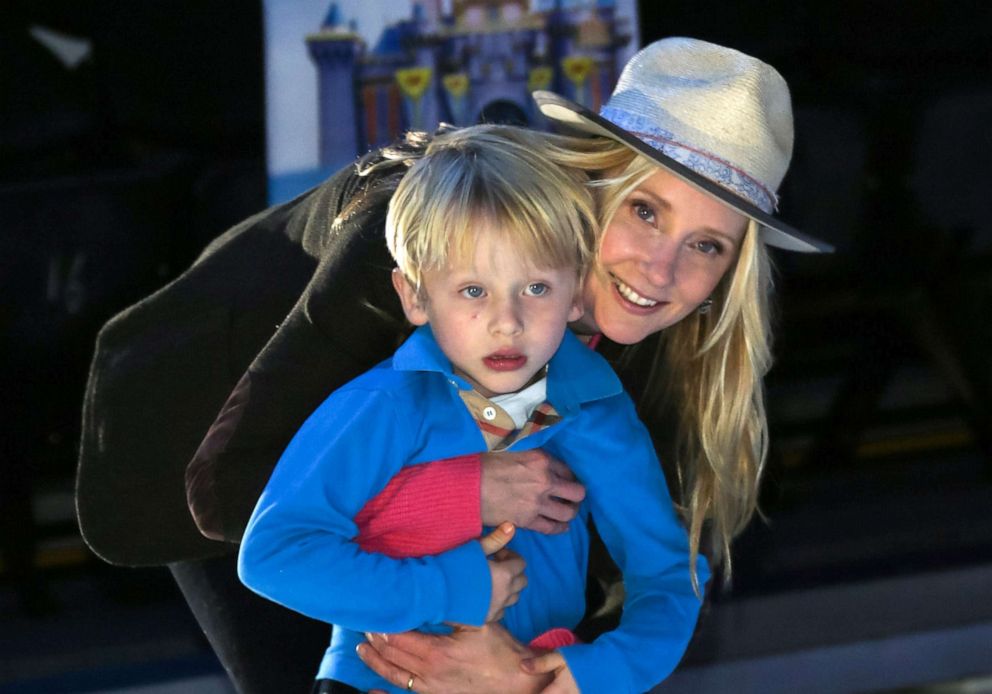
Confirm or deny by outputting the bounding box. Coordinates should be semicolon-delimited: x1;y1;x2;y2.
239;126;705;691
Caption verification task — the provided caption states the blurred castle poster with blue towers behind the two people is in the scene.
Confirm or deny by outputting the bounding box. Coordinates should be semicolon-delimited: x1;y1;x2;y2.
263;0;639;203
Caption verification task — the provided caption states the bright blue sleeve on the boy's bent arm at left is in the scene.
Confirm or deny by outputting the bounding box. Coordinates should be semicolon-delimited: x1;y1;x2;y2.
238;387;491;632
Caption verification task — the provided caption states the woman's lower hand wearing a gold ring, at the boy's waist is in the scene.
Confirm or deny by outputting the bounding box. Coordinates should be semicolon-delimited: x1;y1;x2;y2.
358;624;552;694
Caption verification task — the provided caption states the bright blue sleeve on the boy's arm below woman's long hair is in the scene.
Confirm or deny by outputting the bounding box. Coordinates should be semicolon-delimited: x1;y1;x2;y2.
556;395;709;694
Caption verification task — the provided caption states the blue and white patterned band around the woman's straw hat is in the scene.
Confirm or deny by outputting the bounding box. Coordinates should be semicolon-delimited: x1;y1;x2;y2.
599;106;778;214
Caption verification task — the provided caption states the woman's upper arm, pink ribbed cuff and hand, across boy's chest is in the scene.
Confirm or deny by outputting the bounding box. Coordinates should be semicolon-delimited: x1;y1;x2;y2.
355;450;585;557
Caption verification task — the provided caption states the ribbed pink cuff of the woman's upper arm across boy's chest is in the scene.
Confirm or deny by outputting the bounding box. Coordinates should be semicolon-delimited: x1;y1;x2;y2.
355;453;482;557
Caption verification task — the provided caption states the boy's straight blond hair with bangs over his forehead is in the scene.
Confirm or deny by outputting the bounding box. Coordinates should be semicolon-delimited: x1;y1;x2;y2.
386;125;597;293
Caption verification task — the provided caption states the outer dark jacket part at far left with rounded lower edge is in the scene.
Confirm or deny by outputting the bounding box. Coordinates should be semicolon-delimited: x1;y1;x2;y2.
76;189;317;566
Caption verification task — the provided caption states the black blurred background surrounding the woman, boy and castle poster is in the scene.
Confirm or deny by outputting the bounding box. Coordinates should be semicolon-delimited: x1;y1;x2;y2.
0;0;992;691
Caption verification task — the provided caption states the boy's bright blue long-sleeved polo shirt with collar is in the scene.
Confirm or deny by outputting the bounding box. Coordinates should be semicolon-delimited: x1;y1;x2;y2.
239;326;709;692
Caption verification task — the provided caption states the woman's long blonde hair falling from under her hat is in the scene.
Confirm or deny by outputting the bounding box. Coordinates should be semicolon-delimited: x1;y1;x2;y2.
565;140;772;588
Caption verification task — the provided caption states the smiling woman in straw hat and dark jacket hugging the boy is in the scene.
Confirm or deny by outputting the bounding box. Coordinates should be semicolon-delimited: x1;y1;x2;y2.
79;39;829;692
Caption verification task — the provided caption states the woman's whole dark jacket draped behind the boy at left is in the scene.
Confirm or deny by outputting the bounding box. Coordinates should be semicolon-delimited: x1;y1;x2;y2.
76;151;407;566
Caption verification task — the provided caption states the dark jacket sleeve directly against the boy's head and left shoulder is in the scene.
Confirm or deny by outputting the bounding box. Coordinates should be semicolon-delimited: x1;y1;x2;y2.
186;163;407;542
